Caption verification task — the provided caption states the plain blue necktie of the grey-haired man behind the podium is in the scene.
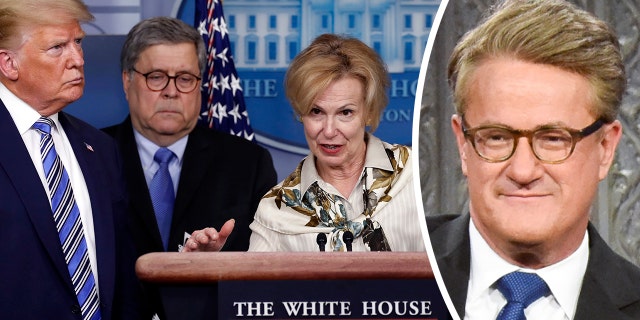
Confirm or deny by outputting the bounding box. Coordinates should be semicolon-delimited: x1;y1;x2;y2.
149;148;175;250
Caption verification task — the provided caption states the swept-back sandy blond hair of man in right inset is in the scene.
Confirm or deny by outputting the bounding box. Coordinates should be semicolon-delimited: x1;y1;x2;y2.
449;0;626;122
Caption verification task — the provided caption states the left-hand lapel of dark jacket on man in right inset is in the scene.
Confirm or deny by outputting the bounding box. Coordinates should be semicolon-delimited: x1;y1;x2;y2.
429;214;471;318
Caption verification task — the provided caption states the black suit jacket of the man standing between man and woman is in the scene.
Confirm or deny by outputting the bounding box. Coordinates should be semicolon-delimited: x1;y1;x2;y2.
104;117;277;320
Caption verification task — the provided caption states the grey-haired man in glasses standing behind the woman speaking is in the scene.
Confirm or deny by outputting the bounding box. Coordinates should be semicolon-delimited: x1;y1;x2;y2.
105;17;276;319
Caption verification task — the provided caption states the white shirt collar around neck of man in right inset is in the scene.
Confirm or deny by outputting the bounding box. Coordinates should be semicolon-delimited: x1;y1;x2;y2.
468;219;589;319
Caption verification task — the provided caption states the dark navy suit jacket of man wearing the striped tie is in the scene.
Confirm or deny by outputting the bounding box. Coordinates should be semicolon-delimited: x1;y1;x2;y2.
0;101;138;319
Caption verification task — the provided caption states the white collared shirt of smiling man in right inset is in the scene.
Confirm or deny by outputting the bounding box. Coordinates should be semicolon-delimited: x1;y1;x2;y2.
464;219;589;320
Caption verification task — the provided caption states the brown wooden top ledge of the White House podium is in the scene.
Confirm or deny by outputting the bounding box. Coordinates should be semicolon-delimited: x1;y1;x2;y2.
136;252;433;283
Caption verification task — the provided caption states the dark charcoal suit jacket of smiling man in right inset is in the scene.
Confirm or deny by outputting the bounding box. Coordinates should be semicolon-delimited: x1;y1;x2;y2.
427;214;640;320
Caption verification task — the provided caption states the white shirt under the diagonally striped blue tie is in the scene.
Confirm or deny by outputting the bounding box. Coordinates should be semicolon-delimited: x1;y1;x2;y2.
0;84;99;288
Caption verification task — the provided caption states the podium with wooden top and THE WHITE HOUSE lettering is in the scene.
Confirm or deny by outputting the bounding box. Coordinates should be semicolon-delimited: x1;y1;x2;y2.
136;252;448;320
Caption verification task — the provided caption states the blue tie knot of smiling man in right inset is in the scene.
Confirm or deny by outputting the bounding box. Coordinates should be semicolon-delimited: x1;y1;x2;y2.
496;271;550;320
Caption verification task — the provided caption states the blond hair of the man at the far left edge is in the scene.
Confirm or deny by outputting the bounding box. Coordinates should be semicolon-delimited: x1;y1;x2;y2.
0;0;93;49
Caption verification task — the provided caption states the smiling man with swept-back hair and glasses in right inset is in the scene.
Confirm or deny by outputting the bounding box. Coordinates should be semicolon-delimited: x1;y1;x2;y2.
427;0;640;319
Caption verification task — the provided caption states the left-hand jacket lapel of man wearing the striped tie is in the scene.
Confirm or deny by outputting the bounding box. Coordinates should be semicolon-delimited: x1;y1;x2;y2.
0;101;74;291
